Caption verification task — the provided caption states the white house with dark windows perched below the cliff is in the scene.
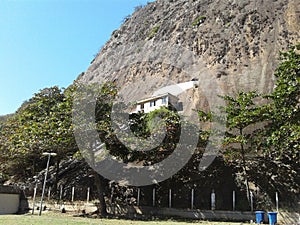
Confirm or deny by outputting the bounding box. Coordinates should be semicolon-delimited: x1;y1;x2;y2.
131;93;178;113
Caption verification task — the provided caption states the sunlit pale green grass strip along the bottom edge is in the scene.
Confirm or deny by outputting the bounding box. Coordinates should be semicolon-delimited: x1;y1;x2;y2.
0;212;248;225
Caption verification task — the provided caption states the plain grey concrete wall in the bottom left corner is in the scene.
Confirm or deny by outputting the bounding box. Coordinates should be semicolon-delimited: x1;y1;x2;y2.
0;193;20;215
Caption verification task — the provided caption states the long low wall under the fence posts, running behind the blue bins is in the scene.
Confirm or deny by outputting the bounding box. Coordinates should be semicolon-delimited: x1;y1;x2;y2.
30;202;300;225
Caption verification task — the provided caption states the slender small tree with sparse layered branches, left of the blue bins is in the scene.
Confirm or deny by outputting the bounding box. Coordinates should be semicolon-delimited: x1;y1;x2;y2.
222;91;261;206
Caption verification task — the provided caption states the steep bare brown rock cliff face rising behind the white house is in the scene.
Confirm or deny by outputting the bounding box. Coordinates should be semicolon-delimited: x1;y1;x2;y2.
79;0;300;111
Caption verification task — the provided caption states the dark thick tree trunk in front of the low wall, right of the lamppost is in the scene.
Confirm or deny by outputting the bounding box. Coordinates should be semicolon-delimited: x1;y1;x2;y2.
94;171;107;217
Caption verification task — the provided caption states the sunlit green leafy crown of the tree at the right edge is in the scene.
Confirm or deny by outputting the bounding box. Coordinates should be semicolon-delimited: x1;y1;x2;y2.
267;44;300;156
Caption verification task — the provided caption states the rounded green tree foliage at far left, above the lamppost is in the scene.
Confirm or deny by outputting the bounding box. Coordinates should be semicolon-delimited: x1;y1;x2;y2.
0;86;77;179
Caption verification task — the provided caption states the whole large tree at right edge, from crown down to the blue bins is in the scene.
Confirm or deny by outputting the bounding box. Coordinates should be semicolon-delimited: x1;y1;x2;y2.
258;44;300;200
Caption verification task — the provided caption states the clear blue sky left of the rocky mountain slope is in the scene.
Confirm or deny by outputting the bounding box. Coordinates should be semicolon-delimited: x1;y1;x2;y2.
0;0;151;115
